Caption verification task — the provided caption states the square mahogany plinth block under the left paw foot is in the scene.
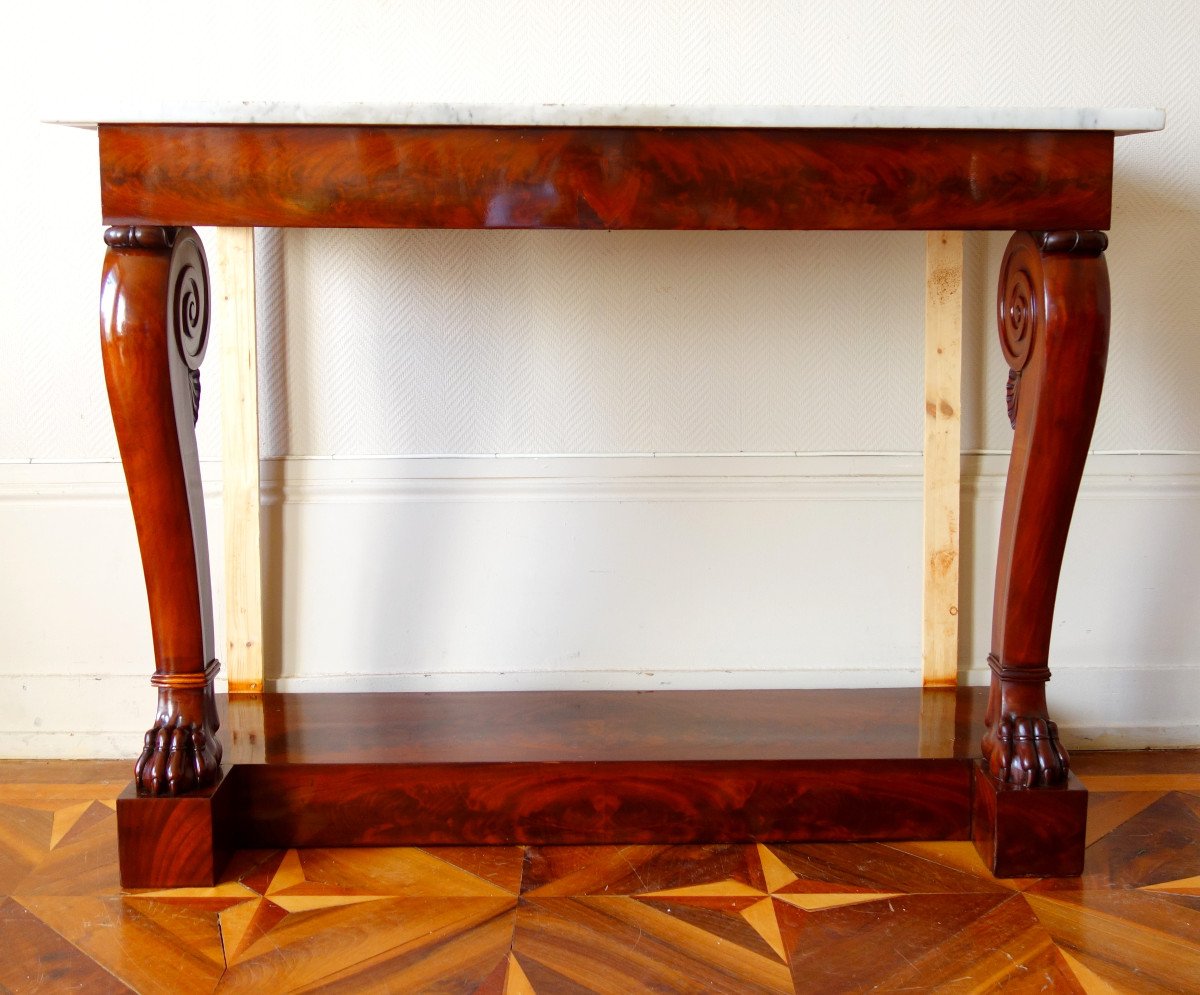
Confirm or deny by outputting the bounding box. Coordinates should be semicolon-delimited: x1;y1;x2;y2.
116;778;233;888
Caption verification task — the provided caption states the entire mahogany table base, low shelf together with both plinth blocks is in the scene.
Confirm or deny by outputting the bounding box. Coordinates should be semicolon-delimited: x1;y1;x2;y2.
116;688;1087;888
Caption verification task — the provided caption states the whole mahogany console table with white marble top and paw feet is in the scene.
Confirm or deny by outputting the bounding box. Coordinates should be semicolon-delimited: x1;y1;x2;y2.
58;104;1163;887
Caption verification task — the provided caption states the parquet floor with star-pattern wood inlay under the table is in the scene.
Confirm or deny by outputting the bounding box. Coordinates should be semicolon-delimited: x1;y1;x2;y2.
0;751;1200;995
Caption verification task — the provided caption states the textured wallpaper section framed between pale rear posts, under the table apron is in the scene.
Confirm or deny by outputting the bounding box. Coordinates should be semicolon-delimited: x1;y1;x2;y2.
259;232;924;456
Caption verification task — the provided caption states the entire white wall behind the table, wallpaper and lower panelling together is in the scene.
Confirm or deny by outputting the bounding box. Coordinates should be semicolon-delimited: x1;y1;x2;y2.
0;0;1200;756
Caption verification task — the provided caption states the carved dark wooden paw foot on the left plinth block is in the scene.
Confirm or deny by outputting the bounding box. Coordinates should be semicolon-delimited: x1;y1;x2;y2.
133;689;221;796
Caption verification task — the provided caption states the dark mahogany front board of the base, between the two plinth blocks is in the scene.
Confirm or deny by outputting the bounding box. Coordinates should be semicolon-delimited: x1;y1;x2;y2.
230;760;971;846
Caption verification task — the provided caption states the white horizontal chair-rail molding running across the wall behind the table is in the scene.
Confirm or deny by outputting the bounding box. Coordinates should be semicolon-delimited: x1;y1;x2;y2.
0;452;1200;504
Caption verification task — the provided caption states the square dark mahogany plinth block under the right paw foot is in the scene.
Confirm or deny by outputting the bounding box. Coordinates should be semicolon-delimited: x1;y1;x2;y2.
972;761;1087;877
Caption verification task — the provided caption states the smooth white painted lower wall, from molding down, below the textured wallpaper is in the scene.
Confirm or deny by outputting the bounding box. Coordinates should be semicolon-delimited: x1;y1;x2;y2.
0;454;1200;756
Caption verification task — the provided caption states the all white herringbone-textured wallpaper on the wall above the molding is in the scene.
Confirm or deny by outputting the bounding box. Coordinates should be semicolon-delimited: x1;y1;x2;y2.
0;0;1200;460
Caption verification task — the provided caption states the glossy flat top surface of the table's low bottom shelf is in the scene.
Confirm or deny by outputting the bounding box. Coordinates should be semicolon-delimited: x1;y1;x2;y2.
243;688;986;765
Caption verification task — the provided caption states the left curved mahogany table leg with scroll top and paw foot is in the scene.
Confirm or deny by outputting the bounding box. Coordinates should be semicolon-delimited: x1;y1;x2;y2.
100;227;221;795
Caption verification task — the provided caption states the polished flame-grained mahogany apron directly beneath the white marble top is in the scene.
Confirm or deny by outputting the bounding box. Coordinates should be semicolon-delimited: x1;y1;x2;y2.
100;125;1112;230
